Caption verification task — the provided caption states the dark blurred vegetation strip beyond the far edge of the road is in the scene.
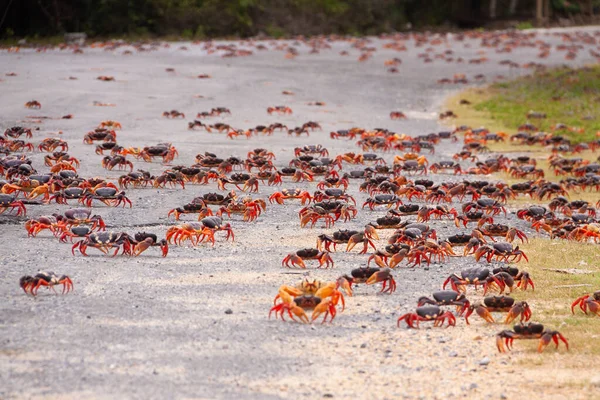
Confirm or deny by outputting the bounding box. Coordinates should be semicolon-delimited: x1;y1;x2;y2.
0;0;600;39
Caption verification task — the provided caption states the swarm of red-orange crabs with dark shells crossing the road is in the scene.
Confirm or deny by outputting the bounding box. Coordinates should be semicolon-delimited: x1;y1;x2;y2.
0;35;600;352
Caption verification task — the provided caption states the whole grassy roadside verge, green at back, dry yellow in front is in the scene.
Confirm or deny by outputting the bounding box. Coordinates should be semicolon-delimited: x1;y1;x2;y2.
445;67;600;366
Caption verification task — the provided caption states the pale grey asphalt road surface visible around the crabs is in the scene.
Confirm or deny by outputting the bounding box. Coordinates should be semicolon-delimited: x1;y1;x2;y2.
0;31;597;399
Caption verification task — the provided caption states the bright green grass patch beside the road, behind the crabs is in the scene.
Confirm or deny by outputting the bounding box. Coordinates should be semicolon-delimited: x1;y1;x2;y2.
472;66;600;143
